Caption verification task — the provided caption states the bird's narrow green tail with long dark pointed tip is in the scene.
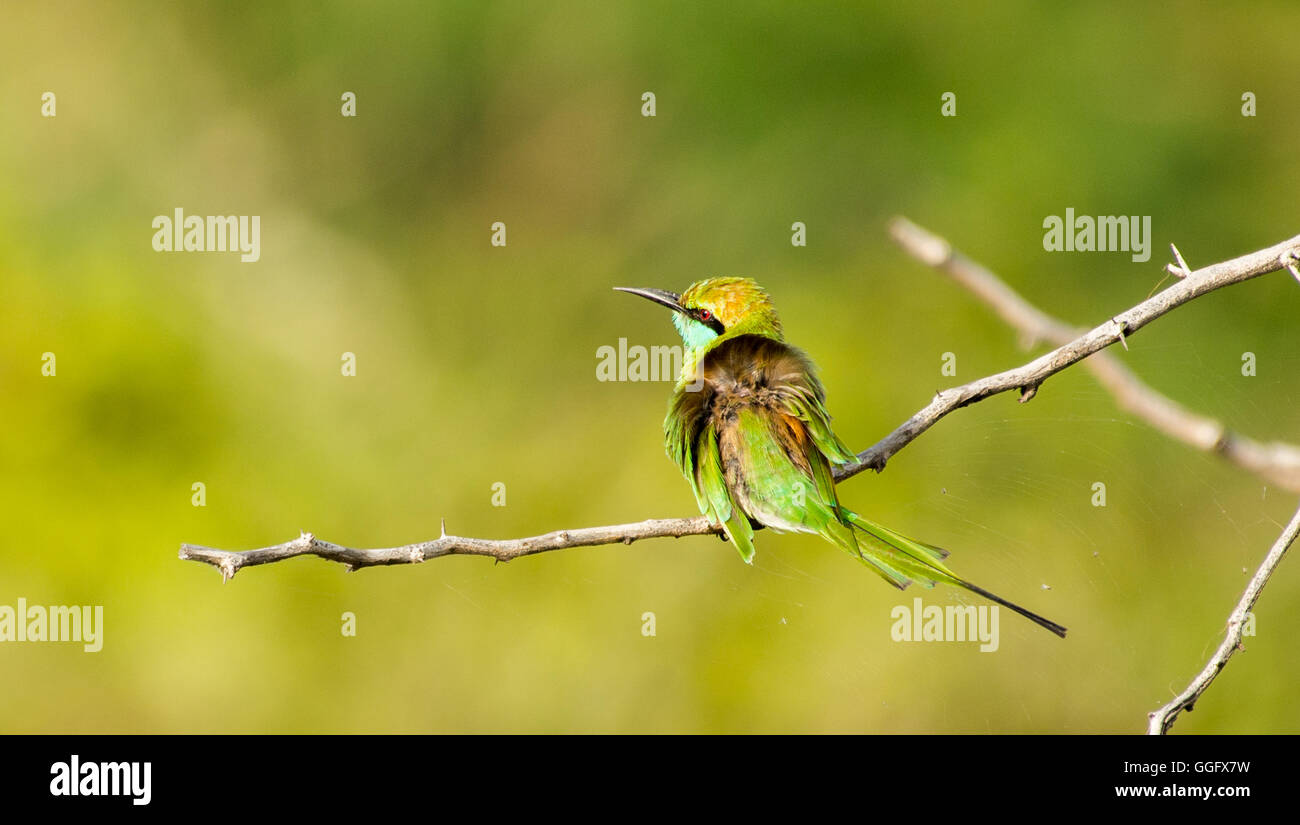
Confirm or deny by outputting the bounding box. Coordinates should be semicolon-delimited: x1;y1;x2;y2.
837;505;1066;639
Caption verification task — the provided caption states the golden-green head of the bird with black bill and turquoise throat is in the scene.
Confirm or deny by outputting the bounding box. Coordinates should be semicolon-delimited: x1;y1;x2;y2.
615;278;781;361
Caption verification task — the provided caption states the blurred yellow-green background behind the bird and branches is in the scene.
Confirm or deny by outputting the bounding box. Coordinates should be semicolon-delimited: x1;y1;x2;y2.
0;3;1300;733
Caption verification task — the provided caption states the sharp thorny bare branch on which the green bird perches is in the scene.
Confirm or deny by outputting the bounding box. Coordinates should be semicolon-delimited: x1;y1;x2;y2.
179;224;1300;579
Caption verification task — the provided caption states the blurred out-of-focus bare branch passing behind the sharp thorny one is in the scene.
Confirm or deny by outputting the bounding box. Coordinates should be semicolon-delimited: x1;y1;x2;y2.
889;218;1300;492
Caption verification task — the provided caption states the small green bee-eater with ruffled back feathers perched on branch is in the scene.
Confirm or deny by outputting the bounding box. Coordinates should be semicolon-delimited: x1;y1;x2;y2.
615;277;1066;638
